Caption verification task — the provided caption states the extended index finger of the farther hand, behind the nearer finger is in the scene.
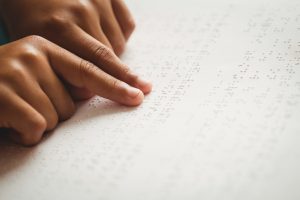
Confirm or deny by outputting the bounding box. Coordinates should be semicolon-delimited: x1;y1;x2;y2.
49;26;152;94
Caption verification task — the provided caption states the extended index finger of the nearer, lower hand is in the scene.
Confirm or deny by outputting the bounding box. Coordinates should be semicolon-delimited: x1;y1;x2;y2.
43;40;144;106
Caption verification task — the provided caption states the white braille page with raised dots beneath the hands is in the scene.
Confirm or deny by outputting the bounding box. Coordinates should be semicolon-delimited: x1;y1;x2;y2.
0;0;300;200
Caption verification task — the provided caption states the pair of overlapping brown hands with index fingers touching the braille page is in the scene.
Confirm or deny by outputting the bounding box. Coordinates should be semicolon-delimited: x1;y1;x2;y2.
0;0;152;145
